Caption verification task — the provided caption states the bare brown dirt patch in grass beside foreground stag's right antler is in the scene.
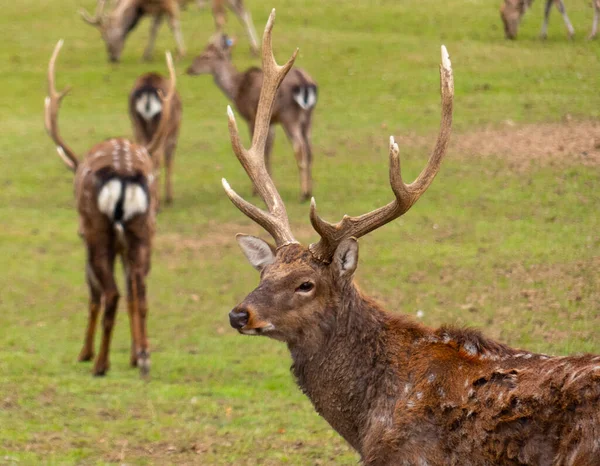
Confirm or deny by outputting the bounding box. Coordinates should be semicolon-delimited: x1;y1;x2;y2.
400;118;600;171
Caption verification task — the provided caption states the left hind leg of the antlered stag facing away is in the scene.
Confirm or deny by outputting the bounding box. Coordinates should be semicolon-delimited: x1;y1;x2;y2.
91;251;119;375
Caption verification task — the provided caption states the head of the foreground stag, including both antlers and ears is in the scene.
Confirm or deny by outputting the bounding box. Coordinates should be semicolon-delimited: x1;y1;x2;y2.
223;10;454;345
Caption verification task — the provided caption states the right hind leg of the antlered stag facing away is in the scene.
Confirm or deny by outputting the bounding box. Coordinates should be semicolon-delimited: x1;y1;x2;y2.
127;242;150;376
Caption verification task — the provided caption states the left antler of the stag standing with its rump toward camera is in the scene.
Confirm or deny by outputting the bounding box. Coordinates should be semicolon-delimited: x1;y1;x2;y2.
44;39;79;171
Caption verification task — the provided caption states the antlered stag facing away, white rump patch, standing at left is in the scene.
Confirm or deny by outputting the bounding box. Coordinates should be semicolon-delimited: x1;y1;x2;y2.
45;41;175;375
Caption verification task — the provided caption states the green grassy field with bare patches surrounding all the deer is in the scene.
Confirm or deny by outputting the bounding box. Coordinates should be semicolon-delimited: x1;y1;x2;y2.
0;0;600;465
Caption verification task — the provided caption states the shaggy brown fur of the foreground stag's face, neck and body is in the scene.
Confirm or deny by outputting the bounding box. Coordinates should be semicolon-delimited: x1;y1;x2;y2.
232;244;600;466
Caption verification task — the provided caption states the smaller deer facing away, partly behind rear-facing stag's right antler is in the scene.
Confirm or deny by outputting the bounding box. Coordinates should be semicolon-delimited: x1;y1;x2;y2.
129;73;182;204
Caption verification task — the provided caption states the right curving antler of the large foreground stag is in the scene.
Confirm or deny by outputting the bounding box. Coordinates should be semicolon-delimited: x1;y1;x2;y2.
310;45;454;262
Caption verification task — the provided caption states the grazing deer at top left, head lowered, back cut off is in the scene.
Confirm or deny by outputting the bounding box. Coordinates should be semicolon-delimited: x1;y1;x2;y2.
80;0;258;62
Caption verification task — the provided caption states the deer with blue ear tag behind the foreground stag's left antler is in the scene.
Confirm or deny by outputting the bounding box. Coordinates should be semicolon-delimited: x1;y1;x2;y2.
187;34;317;200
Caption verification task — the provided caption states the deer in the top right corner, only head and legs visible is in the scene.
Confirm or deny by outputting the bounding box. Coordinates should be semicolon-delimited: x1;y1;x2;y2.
500;0;600;40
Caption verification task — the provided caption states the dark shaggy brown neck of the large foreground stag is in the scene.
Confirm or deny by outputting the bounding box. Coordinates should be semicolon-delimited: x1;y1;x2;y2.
288;284;426;452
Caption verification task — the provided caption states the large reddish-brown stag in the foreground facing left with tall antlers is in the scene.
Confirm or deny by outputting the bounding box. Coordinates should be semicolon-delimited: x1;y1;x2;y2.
223;9;600;466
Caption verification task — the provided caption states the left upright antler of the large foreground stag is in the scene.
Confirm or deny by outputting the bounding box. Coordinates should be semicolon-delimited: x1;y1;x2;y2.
222;9;298;247
